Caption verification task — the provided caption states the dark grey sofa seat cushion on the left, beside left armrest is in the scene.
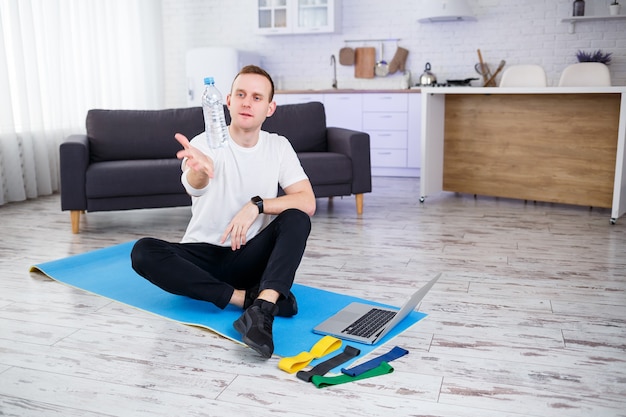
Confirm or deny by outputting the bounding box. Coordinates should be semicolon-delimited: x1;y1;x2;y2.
85;158;186;198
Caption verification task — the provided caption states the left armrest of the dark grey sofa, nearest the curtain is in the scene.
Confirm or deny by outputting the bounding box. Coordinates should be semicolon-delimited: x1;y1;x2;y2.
59;135;89;210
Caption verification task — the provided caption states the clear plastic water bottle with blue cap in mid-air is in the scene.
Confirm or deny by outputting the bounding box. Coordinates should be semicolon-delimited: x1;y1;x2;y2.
202;77;228;149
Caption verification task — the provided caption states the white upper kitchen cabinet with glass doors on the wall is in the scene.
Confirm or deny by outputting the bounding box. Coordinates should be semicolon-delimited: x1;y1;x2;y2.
254;0;341;35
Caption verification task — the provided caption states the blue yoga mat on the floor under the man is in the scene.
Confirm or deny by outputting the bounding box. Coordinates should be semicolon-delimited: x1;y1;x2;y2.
30;241;426;366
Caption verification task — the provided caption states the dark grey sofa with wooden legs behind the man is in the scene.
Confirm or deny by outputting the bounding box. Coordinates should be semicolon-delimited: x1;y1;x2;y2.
60;102;372;233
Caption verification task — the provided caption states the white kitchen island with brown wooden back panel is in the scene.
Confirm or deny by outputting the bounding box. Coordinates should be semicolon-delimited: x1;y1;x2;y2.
420;87;626;223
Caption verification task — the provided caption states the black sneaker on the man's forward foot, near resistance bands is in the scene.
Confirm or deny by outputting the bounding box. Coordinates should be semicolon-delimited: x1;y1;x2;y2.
233;300;278;358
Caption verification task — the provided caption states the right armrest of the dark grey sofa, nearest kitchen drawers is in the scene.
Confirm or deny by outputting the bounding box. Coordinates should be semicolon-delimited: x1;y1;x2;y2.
326;127;372;194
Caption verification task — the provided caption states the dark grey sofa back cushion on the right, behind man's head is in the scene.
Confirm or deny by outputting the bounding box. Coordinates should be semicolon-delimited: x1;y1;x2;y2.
226;101;328;152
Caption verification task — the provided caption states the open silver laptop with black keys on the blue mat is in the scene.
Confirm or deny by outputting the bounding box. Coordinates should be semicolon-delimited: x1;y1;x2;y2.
313;273;441;345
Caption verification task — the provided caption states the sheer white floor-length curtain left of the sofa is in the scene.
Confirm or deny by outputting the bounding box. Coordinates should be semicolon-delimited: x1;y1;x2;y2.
0;0;163;205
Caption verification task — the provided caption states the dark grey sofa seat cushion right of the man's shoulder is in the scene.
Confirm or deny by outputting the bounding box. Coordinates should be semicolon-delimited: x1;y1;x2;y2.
298;152;352;186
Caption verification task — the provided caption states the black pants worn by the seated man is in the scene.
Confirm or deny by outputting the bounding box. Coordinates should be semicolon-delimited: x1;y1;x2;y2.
130;209;311;308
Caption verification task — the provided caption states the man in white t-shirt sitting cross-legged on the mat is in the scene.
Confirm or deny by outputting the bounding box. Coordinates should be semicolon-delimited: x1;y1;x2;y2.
131;65;316;358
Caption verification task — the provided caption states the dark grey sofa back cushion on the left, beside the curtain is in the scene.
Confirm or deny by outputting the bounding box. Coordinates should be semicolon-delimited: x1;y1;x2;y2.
87;107;204;162
